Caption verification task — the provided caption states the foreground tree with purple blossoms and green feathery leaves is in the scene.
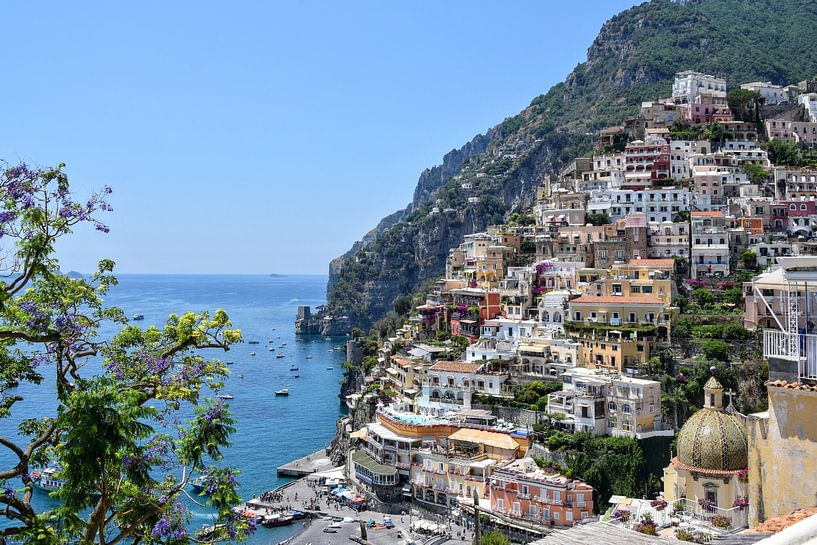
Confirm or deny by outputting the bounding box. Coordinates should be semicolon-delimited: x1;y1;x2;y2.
0;165;253;545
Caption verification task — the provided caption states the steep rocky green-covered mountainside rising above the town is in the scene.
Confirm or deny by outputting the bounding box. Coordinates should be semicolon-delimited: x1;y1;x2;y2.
327;0;817;327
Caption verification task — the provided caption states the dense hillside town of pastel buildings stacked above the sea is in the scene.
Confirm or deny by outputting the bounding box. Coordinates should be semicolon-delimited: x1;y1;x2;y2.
300;71;817;544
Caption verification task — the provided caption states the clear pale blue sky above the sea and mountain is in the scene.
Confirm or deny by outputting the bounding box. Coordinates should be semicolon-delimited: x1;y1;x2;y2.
0;0;636;273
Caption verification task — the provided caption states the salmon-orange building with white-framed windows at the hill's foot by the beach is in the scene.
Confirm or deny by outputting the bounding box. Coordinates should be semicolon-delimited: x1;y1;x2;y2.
490;458;593;526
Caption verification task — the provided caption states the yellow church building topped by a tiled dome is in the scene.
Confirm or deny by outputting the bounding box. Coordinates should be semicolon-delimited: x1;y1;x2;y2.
663;377;748;528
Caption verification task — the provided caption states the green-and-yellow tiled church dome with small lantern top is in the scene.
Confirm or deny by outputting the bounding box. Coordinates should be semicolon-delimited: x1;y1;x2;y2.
678;378;749;471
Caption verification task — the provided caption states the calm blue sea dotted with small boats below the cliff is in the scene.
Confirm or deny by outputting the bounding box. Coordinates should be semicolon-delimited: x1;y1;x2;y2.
0;274;346;545
